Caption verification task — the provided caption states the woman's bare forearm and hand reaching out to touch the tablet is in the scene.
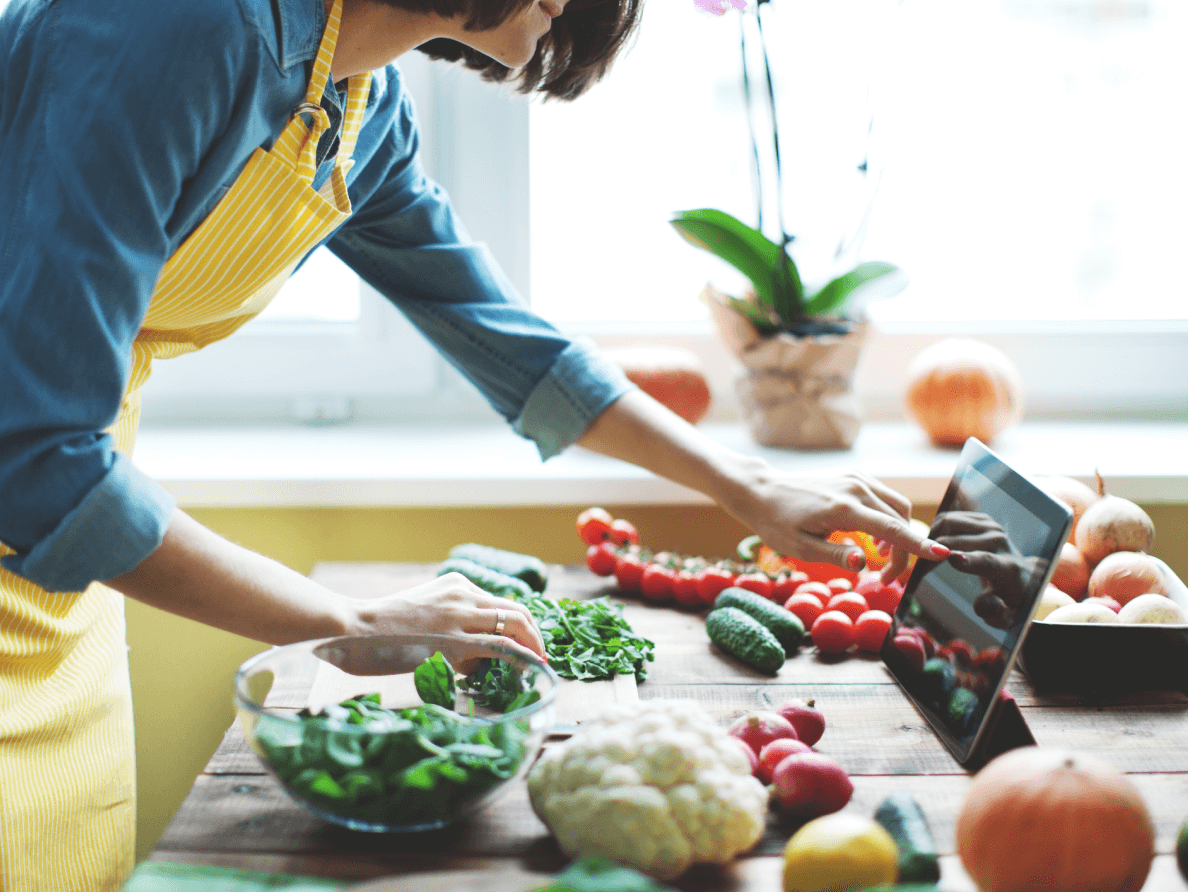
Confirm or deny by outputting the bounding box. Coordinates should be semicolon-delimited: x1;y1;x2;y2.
577;391;949;578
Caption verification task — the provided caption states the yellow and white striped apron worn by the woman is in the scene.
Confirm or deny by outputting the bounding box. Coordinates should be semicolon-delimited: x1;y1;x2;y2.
0;0;371;892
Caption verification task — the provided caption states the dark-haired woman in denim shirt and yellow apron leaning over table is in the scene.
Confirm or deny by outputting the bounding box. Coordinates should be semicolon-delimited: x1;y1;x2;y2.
0;0;943;892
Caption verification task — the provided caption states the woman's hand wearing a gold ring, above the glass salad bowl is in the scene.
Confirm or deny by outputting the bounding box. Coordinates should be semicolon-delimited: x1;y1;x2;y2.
352;572;545;668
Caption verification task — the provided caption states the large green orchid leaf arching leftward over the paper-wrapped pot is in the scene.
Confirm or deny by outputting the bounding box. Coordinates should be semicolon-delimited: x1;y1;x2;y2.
669;208;803;318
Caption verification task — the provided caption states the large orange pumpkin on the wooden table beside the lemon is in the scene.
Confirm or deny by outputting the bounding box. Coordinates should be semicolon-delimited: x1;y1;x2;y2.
956;746;1155;892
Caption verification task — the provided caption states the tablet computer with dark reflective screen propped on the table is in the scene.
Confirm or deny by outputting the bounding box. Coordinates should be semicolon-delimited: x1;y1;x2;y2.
880;438;1073;765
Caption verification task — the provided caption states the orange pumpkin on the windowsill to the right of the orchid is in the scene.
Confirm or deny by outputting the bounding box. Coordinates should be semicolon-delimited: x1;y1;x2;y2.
904;337;1023;445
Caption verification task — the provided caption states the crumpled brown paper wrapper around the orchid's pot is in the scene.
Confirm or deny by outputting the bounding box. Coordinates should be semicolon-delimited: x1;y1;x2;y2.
701;285;866;449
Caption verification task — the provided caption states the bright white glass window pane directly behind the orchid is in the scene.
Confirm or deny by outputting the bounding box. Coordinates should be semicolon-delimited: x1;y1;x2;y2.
531;0;1188;322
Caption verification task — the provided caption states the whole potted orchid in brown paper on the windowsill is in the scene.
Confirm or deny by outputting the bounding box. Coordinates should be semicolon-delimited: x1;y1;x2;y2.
670;0;905;448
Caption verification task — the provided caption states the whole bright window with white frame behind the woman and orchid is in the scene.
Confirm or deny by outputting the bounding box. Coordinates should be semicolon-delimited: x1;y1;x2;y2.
146;0;1188;418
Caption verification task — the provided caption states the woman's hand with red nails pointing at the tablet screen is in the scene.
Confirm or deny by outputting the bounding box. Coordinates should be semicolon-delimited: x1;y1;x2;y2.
738;472;949;582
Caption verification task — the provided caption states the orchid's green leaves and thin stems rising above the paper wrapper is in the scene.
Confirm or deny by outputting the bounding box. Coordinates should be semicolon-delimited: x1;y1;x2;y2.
669;0;902;336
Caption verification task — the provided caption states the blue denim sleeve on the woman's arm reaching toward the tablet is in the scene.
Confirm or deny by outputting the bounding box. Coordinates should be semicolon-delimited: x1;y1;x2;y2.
329;68;634;458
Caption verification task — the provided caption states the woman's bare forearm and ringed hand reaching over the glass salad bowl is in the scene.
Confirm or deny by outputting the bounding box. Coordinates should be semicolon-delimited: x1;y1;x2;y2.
107;511;544;665
